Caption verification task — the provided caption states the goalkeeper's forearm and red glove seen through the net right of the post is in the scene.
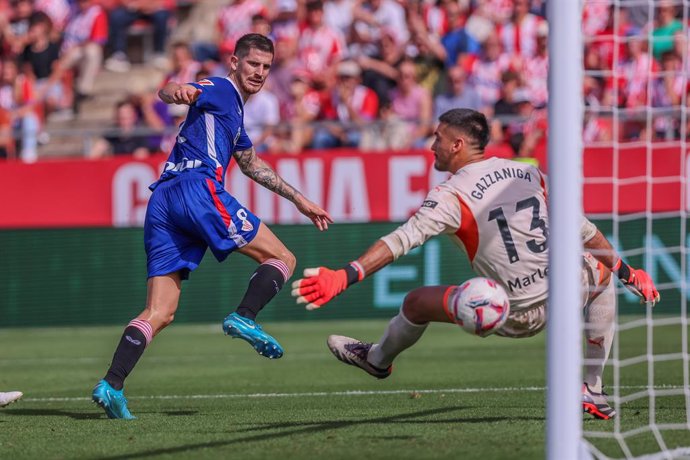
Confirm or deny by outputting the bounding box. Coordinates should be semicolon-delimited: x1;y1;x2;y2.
584;229;661;306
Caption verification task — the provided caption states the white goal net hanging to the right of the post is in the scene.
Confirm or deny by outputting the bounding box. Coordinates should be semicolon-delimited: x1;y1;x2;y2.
582;0;690;458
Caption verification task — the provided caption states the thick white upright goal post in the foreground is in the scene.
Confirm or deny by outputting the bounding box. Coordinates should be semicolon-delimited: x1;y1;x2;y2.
546;0;582;460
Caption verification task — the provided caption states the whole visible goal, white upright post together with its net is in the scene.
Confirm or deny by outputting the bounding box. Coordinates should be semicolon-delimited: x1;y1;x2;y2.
546;0;690;460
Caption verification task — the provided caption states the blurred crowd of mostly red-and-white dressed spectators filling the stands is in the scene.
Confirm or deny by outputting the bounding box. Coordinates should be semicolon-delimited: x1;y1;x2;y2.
0;0;689;161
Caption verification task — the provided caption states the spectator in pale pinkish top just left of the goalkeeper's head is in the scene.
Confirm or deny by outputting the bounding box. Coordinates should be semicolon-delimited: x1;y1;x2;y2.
391;59;432;147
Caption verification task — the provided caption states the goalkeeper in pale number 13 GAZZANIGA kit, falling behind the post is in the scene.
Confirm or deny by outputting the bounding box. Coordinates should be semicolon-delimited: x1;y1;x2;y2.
292;109;659;419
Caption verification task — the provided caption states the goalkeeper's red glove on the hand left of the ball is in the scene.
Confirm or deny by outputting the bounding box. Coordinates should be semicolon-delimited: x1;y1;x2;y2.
292;262;364;310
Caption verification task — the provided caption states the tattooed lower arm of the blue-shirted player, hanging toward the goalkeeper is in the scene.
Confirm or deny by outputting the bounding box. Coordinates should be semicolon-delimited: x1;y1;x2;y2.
233;147;333;231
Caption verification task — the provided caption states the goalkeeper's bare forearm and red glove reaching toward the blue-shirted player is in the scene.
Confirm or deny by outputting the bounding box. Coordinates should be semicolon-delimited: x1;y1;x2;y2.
292;240;394;310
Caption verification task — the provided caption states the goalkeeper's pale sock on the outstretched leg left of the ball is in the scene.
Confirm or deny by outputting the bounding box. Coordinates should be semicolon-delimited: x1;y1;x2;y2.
367;310;429;369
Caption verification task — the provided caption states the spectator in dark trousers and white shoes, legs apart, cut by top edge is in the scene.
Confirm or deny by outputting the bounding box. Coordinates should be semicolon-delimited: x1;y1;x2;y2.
105;0;172;72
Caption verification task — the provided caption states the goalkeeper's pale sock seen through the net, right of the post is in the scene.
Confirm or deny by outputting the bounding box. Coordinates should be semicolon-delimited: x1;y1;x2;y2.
585;280;616;393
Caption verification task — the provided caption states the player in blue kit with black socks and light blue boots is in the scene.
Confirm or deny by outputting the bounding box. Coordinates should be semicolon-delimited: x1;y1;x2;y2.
93;34;333;419
